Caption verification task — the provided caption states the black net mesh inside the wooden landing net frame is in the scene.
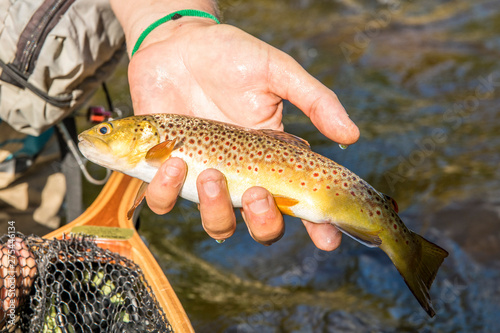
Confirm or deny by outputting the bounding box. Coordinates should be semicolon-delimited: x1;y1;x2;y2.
0;234;173;333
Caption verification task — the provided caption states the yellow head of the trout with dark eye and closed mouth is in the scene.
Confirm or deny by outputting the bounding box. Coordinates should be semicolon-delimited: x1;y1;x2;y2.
78;117;160;172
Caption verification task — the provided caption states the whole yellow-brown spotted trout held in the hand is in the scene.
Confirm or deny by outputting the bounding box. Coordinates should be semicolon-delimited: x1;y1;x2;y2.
78;114;448;316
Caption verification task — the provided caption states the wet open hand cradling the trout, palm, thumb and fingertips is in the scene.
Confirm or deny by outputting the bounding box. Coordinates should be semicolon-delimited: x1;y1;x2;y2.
112;1;359;250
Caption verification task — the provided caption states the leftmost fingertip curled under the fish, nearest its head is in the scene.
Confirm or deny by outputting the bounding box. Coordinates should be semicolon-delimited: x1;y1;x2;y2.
146;157;187;214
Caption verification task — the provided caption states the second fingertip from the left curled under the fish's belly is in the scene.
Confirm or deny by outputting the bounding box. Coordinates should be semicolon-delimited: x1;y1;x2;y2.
196;169;236;240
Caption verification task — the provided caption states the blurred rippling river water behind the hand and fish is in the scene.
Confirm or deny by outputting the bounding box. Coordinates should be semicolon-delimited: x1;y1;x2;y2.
86;0;500;333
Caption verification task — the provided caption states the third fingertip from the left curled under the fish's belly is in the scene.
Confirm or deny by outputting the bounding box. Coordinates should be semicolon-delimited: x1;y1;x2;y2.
241;187;285;245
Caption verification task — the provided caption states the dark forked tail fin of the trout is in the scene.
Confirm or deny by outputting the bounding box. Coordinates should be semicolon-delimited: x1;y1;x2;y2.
395;233;448;317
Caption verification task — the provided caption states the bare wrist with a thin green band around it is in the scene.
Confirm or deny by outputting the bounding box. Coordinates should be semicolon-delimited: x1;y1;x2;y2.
110;0;217;56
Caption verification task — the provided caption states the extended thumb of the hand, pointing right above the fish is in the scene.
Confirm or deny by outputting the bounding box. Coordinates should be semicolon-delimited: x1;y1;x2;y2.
269;51;359;145
